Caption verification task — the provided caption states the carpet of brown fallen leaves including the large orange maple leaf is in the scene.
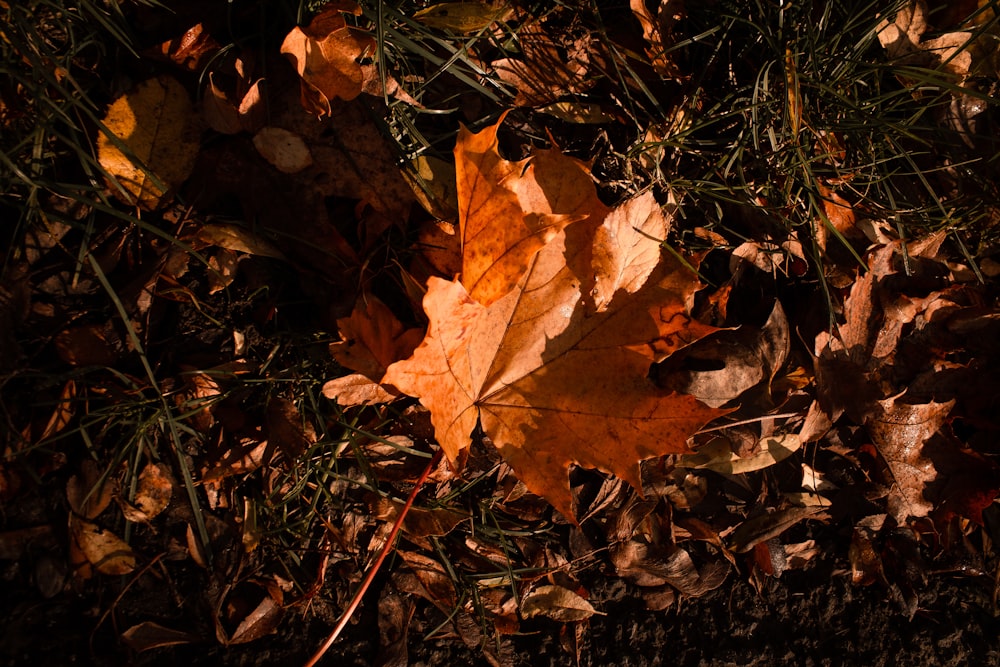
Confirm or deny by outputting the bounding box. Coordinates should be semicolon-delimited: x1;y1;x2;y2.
0;2;1000;664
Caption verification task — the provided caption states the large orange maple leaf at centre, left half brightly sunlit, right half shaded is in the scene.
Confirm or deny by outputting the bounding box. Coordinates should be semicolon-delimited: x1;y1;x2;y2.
383;194;727;519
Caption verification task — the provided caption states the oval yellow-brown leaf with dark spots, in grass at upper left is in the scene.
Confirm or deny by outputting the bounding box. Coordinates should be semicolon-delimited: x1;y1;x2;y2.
97;76;201;210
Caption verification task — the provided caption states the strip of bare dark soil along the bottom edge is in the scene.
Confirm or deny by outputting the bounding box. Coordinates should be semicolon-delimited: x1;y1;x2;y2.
0;540;1000;667
